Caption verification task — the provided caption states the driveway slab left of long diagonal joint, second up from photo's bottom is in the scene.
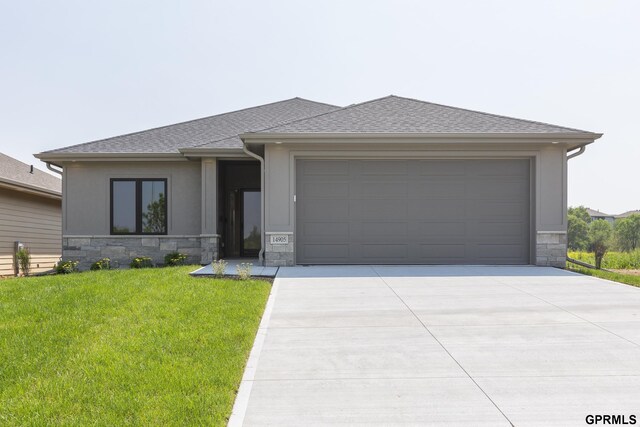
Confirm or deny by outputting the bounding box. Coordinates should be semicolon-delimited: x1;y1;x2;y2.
255;326;466;380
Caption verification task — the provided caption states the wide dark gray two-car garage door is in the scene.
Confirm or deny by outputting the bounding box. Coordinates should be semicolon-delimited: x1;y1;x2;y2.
296;159;530;264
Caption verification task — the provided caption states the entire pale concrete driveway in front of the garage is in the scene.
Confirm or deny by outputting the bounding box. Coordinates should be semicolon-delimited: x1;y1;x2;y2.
230;266;640;426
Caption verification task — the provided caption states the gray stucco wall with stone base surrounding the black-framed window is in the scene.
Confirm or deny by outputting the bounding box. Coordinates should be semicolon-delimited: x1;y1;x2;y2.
62;159;219;270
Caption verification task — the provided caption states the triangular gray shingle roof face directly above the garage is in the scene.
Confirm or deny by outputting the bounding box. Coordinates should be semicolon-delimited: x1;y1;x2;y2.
252;95;585;134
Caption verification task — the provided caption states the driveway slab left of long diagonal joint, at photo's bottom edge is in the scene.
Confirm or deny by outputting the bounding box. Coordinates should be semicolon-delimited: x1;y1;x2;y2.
244;378;509;427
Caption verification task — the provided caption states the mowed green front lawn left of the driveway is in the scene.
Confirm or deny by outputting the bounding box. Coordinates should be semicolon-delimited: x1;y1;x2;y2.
0;266;270;426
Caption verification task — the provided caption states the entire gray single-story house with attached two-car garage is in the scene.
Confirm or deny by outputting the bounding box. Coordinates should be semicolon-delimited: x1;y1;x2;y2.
36;96;601;268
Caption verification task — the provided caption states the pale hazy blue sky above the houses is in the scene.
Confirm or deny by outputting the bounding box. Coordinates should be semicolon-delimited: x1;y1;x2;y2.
0;0;640;213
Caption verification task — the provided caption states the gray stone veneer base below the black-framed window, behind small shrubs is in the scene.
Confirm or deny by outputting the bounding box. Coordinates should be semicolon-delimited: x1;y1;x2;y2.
62;235;219;270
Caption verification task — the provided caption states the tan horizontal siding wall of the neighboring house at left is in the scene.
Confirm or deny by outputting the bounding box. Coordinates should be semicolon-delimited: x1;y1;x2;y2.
0;188;62;276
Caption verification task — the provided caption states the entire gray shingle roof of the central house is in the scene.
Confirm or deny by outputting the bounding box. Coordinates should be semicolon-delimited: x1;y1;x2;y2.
42;95;595;155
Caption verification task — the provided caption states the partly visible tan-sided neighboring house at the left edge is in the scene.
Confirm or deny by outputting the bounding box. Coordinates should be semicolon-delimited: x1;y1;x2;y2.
0;153;62;276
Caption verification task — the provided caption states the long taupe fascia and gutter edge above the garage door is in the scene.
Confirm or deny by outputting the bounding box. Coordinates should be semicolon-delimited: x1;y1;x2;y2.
240;132;602;149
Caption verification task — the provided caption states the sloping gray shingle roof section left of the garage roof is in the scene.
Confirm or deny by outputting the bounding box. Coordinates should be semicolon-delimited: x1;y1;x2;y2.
45;98;340;153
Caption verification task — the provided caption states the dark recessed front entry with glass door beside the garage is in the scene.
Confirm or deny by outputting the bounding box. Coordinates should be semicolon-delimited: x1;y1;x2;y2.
218;161;261;258
